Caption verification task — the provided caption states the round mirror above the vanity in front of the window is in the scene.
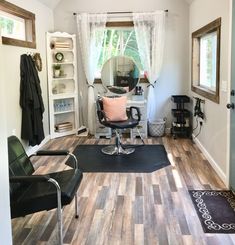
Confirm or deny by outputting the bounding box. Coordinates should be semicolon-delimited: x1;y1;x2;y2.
101;56;140;94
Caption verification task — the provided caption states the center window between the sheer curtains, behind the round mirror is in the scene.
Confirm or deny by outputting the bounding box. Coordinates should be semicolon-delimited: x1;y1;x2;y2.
96;22;143;82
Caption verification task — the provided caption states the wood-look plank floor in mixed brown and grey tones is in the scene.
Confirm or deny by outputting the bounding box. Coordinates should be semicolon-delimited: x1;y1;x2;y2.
12;136;235;245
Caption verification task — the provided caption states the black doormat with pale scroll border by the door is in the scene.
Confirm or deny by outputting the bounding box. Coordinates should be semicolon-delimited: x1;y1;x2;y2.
189;190;235;233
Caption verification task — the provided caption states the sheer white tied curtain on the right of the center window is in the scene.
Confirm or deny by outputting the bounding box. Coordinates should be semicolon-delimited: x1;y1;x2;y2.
133;11;166;121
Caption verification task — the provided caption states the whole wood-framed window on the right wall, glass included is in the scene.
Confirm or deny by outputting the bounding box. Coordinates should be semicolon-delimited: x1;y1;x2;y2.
192;18;221;103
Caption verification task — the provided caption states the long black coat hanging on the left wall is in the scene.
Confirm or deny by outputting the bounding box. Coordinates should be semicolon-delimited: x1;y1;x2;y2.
20;54;44;146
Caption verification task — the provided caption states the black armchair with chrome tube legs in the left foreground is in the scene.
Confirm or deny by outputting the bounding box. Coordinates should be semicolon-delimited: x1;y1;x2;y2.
8;136;83;244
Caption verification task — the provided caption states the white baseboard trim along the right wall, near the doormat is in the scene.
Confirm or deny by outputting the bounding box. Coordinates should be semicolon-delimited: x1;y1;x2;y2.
192;135;227;184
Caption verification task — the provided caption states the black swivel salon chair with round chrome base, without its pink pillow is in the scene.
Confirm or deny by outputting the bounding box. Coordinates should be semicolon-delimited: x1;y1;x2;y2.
96;97;140;155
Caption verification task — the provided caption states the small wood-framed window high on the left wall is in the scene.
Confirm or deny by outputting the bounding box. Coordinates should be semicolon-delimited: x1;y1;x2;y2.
0;1;36;48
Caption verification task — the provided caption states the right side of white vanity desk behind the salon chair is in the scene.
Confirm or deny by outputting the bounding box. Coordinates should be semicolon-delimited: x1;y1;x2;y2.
127;100;148;139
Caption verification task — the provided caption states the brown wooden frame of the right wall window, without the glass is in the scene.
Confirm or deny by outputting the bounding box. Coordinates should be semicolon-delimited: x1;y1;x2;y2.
191;18;221;104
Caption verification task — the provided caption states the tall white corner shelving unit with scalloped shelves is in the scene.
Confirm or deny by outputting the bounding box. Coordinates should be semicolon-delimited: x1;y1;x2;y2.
47;32;79;138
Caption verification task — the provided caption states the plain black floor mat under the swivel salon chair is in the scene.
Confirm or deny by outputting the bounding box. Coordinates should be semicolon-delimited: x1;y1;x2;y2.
66;145;170;173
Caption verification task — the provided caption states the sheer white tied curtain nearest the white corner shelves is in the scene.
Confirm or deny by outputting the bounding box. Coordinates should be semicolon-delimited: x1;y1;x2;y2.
77;13;107;134
